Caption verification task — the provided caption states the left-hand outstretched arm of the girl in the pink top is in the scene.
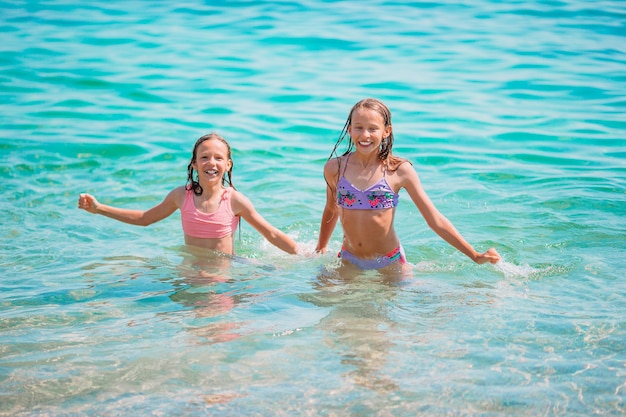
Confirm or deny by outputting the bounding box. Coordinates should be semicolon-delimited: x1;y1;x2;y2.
78;187;185;226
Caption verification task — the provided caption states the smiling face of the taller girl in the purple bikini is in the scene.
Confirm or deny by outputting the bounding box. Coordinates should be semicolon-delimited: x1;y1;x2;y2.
348;107;391;153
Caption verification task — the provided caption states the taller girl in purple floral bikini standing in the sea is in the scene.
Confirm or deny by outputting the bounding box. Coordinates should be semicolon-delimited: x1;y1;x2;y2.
316;98;500;270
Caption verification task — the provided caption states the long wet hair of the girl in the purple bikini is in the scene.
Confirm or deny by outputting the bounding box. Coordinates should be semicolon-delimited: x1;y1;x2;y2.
328;98;407;171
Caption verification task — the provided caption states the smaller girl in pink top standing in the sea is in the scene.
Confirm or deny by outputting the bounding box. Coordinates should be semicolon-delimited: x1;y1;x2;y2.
78;133;298;254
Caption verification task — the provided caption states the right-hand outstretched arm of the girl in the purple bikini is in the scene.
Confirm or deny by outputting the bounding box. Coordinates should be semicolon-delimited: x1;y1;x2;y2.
398;163;500;264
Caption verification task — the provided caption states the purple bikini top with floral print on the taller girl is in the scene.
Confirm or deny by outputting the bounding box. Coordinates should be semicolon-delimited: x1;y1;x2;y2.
337;154;398;210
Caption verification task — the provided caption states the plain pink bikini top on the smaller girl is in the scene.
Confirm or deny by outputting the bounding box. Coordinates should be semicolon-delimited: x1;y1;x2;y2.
180;187;239;239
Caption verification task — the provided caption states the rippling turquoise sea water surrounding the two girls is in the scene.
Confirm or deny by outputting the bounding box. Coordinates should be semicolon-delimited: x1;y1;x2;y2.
0;0;626;416
